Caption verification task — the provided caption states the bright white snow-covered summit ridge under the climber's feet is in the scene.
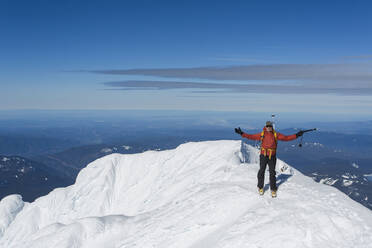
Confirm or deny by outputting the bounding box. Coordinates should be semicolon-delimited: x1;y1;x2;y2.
0;141;372;248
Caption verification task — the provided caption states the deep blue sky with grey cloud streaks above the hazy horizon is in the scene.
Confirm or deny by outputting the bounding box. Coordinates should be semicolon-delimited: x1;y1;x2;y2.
0;0;372;118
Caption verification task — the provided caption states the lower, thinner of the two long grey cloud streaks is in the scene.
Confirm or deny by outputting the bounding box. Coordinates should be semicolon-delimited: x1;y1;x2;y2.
104;80;372;95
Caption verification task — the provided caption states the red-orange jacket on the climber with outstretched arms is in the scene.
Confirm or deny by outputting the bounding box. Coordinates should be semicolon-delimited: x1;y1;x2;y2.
242;128;297;155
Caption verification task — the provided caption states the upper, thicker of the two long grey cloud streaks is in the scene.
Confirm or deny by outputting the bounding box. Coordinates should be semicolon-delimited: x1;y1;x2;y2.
91;64;372;82
